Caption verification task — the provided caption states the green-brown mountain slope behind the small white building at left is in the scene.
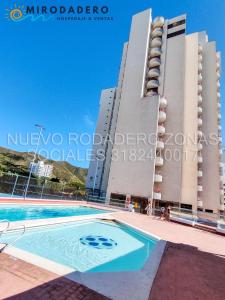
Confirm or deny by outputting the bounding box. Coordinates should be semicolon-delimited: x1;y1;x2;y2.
0;147;87;186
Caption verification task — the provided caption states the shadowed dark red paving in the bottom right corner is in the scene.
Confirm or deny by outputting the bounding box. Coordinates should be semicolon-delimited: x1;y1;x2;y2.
149;243;225;300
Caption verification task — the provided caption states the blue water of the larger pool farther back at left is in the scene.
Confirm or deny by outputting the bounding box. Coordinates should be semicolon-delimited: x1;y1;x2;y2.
0;205;109;221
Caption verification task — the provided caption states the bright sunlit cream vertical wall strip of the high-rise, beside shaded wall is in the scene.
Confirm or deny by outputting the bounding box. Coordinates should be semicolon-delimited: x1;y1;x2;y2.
181;33;198;210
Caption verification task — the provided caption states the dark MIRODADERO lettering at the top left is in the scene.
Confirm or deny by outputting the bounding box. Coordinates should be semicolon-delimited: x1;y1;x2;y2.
26;5;109;14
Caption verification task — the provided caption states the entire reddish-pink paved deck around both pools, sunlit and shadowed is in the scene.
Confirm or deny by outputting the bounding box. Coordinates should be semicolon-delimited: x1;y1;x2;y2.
0;199;225;300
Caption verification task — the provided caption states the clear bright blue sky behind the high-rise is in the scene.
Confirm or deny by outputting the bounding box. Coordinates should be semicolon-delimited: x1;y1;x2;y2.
0;0;225;167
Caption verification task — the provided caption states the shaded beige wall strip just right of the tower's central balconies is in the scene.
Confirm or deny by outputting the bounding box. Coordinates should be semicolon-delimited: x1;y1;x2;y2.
161;34;185;202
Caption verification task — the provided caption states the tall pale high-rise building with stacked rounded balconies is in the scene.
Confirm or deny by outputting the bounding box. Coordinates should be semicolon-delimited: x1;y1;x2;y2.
86;9;224;213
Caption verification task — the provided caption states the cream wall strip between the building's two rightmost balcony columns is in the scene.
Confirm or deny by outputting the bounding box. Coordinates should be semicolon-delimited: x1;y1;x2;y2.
201;42;220;212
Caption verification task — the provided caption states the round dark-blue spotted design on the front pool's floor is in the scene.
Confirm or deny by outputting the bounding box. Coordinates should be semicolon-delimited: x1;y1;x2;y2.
80;235;117;249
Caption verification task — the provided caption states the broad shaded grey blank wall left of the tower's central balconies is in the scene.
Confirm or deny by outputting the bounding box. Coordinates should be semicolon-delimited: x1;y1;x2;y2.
107;10;158;197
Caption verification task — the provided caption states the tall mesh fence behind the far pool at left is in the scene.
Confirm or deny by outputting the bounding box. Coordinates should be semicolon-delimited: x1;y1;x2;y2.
0;173;86;200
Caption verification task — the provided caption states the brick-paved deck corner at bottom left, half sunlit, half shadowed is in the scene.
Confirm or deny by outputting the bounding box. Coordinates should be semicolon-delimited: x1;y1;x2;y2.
0;253;108;300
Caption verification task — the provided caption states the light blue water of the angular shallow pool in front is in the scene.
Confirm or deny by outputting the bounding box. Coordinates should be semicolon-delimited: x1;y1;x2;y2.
0;220;158;272
